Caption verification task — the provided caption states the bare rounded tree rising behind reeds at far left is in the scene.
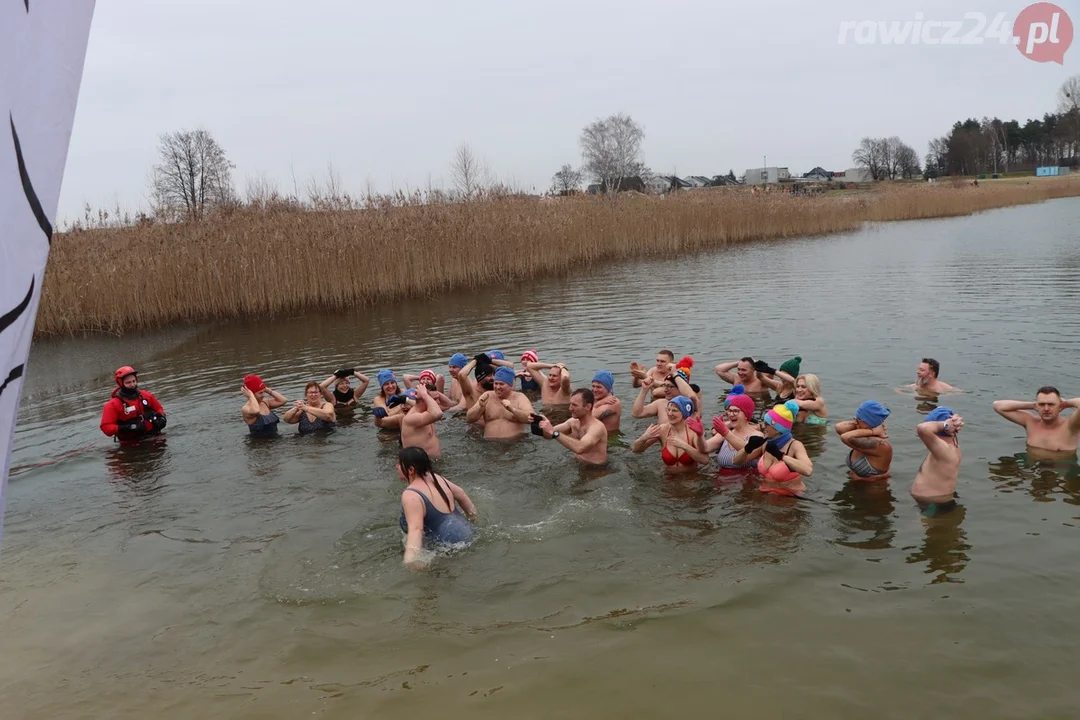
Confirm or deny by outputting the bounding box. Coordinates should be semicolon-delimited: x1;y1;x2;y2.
151;128;237;220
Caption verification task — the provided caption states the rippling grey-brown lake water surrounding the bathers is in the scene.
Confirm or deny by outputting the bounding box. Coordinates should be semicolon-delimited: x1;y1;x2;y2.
0;200;1080;720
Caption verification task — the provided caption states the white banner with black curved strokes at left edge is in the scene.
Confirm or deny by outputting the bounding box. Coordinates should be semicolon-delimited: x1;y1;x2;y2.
0;0;94;548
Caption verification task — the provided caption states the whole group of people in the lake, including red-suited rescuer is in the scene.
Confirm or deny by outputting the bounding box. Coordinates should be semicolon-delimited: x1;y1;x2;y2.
100;350;1080;565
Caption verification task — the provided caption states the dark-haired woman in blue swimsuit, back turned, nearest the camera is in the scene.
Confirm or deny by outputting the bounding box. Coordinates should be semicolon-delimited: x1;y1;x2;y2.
397;447;476;567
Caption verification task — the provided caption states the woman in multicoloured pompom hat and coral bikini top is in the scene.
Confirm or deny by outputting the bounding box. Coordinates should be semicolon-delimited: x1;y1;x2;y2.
732;400;813;497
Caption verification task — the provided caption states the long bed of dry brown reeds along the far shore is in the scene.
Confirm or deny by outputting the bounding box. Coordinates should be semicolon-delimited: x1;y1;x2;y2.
36;178;1080;336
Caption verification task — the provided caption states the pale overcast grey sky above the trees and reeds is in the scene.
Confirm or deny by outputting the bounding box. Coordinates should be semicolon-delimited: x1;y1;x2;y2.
58;0;1080;221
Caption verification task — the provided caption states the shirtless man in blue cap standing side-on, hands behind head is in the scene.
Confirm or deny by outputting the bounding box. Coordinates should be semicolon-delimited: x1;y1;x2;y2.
912;407;963;517
